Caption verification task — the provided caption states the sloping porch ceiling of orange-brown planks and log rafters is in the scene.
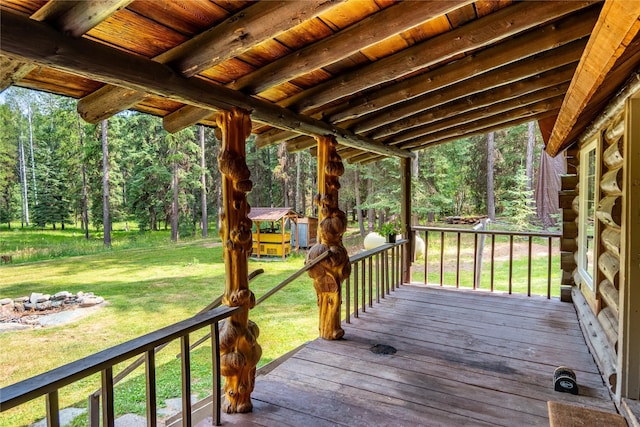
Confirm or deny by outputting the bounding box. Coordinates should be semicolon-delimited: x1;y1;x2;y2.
0;0;640;162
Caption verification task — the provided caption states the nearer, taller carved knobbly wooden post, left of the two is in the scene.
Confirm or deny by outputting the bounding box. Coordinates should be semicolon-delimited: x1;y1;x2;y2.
217;108;262;413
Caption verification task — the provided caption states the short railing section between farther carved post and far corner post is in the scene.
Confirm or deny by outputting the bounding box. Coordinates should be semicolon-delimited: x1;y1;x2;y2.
343;239;408;323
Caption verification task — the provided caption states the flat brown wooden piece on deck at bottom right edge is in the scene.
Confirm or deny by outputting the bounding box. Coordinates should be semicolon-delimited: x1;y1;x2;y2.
548;401;627;427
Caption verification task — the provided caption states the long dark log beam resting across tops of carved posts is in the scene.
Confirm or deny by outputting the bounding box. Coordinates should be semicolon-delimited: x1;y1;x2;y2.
0;12;413;157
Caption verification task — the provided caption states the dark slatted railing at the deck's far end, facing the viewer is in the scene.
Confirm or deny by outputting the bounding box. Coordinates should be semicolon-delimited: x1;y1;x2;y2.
412;226;560;298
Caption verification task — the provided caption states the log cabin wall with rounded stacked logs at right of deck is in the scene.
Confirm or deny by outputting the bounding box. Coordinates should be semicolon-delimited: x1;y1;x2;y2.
559;84;638;397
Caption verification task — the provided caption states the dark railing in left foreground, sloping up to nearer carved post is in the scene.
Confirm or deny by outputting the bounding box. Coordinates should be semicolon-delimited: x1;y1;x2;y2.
0;306;240;427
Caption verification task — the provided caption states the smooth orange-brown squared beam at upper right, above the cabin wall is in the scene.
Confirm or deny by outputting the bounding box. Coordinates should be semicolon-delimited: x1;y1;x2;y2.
547;0;640;156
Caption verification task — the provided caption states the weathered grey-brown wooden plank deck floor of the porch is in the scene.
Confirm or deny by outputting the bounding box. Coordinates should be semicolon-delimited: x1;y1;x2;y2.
206;285;616;426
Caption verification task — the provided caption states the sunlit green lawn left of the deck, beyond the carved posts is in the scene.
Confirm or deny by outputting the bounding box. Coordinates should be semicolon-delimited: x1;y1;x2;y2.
0;226;317;427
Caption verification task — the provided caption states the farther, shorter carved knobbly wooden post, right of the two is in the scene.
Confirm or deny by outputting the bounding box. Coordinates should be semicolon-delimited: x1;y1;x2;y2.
307;136;351;340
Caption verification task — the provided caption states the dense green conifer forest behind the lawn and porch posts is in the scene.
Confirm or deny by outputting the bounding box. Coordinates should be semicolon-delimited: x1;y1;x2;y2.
0;88;542;240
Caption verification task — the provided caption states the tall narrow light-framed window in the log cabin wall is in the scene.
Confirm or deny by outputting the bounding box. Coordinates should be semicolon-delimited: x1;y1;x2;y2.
578;140;597;289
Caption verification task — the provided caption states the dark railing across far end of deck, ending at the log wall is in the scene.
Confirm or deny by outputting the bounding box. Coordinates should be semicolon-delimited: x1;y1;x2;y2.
413;226;560;298
